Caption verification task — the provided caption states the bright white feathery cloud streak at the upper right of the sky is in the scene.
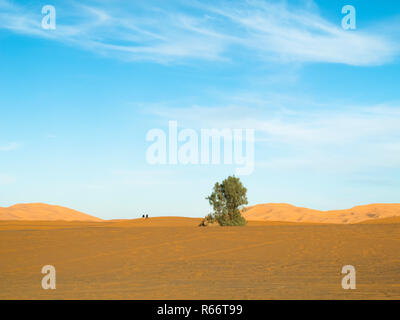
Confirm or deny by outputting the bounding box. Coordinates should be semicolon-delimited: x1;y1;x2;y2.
205;1;398;65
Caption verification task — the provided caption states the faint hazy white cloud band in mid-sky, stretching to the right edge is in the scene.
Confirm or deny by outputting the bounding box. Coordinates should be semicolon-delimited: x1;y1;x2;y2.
147;101;400;146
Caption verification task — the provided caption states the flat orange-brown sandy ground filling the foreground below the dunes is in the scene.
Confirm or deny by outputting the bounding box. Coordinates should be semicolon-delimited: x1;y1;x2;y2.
0;218;400;299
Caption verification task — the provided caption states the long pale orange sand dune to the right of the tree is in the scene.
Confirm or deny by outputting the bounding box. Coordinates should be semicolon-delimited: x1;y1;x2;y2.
243;203;400;224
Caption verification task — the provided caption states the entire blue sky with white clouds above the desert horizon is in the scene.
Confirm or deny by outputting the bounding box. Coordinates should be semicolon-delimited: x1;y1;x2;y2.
0;0;400;219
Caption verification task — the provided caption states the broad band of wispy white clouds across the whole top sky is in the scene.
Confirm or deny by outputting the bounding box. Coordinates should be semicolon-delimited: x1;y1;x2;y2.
0;0;399;66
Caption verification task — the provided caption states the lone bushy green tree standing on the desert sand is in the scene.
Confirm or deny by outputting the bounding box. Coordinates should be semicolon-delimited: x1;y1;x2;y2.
205;176;248;226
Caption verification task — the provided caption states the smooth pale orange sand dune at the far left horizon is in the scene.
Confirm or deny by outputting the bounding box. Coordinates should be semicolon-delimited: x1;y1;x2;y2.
0;203;102;221
